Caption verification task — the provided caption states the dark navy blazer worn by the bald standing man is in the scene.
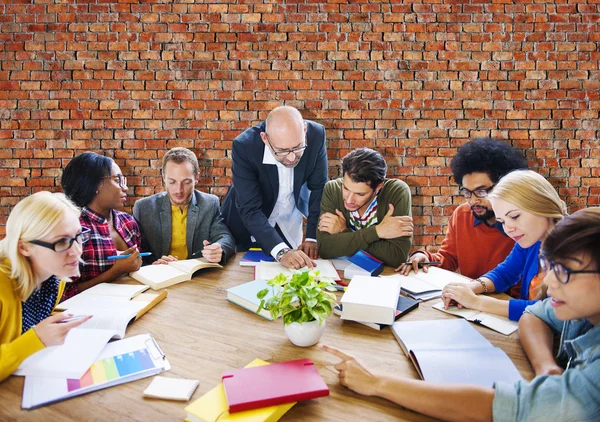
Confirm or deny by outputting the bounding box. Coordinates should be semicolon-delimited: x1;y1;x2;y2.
222;120;327;255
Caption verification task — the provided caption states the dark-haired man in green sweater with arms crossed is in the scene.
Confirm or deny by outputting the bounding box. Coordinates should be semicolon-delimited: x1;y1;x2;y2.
317;148;413;267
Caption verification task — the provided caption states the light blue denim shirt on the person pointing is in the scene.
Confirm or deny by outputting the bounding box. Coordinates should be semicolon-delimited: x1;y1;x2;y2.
492;299;600;422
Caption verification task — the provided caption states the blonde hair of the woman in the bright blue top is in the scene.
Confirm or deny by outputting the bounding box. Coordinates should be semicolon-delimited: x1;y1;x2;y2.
488;170;567;223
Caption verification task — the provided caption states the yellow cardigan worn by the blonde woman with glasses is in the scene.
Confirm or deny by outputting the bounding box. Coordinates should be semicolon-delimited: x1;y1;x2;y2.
0;261;65;381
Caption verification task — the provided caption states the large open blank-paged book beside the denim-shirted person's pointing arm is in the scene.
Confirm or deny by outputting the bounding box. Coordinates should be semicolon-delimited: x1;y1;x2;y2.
392;319;522;387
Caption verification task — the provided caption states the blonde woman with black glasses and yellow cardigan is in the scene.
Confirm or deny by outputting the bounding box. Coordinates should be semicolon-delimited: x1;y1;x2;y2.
0;192;91;381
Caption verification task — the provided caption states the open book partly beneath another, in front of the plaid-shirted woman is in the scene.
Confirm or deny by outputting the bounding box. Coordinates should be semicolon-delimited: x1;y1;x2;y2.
56;283;167;319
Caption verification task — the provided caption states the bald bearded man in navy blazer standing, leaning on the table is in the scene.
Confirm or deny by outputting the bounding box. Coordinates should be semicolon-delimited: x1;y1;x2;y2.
223;106;327;269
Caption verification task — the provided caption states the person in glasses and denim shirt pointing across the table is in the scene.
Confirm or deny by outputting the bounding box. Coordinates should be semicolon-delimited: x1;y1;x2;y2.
322;208;600;421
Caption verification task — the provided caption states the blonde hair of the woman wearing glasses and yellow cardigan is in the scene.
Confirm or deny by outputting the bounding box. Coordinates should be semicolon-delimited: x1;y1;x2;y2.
0;192;80;301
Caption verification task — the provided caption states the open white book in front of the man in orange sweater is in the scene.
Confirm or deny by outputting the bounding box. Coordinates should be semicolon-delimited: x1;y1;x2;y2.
387;267;471;301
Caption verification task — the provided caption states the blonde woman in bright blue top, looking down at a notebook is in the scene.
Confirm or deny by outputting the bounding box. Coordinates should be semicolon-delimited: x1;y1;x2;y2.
442;170;567;321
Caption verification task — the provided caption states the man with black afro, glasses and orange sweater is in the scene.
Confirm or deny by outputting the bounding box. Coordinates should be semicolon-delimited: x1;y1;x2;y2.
396;138;527;278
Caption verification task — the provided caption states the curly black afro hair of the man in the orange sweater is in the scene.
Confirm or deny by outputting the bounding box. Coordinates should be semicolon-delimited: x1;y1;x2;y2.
450;138;528;185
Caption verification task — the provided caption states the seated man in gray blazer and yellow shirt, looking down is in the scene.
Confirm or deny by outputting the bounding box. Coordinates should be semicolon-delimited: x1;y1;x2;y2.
133;148;235;264
